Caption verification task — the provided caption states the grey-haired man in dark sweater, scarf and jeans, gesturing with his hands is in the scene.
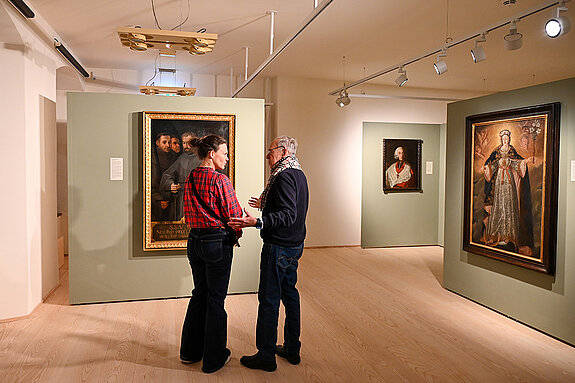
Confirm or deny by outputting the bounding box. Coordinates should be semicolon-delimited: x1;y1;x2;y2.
229;136;309;371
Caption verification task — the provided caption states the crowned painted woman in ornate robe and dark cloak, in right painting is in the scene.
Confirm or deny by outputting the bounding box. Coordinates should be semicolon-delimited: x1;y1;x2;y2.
483;129;533;255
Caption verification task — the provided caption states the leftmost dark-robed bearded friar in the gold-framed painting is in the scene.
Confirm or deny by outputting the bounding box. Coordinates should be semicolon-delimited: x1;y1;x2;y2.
151;132;176;221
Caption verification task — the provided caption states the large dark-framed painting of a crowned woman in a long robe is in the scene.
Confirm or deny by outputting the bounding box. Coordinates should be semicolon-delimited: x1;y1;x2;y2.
463;103;560;274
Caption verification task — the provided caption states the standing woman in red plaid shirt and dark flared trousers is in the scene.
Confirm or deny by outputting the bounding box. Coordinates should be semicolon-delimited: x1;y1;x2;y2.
180;135;242;373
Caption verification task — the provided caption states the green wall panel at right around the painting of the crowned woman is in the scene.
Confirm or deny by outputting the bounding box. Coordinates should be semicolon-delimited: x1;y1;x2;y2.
443;78;575;344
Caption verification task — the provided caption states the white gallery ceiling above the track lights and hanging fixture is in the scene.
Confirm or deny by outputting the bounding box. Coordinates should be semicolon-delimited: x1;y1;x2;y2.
21;0;575;93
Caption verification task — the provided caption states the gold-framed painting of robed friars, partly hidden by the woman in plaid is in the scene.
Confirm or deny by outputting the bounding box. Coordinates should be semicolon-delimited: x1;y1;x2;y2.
143;112;235;251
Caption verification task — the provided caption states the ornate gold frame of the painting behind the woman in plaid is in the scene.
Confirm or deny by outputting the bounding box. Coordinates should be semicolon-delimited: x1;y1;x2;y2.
143;112;236;251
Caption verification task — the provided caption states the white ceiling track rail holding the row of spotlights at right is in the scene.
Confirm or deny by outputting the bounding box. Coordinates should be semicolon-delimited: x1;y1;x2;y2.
329;0;561;96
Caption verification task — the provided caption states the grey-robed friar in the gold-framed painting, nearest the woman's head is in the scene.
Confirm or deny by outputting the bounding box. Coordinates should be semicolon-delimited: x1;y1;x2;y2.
160;132;202;221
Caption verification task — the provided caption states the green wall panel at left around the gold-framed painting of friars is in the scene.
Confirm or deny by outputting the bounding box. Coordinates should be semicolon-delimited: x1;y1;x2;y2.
68;93;264;303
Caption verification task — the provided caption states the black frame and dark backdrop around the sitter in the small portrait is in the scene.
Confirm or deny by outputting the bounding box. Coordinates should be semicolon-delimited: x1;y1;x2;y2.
383;138;423;194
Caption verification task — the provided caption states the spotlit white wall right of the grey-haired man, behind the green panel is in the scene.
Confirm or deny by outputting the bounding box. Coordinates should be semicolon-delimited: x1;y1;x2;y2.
274;77;454;246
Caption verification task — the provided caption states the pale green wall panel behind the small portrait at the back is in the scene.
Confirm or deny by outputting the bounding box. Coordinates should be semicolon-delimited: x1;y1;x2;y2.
361;122;440;247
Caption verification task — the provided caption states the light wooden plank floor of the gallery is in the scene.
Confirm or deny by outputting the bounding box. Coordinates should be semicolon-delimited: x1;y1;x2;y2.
0;247;575;383
